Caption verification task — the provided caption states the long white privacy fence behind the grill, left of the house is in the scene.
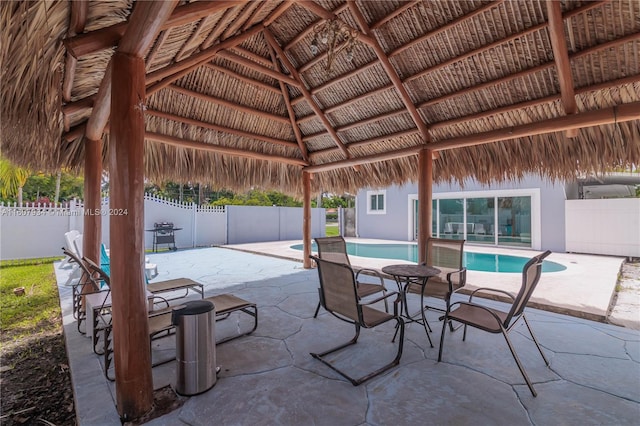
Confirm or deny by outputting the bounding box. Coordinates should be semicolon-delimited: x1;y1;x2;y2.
0;194;325;260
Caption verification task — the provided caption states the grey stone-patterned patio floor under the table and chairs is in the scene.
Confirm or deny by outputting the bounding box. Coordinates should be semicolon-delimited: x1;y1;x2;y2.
56;242;640;426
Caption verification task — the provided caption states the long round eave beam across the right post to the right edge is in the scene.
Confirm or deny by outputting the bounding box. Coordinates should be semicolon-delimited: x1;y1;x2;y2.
303;102;640;173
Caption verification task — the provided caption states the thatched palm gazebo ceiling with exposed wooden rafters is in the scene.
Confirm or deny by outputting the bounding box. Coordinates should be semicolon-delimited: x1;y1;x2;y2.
0;0;640;194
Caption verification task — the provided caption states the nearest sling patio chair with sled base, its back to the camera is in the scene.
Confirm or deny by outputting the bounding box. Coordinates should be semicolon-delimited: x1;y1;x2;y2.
311;256;404;386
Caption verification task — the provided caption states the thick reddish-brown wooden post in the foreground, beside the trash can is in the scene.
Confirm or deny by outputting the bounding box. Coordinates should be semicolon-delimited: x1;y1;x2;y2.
109;52;153;421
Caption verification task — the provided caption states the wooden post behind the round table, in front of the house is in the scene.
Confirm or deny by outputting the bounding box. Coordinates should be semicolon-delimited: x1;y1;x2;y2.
418;149;433;262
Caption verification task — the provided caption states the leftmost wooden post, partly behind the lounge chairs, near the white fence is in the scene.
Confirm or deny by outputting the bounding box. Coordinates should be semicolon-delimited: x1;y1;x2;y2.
82;138;102;268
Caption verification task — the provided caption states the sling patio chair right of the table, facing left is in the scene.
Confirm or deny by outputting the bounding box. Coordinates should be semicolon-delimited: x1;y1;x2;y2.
438;251;551;396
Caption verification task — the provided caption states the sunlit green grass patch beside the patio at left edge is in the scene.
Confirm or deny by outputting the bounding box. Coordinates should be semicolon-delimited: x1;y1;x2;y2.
0;259;60;342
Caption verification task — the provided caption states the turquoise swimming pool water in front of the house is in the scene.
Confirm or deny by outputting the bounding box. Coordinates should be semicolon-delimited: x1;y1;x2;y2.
291;243;567;273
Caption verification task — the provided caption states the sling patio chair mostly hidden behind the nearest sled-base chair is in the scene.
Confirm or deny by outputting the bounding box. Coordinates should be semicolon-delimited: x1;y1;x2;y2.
313;236;389;318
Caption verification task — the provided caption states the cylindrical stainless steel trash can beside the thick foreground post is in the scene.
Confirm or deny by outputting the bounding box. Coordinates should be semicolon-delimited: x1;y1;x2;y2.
171;300;216;395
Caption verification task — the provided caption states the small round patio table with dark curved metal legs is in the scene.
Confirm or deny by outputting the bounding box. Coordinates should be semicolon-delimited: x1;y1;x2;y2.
382;264;441;347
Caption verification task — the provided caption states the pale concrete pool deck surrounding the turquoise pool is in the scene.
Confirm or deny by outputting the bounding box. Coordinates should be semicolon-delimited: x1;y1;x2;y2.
224;238;624;322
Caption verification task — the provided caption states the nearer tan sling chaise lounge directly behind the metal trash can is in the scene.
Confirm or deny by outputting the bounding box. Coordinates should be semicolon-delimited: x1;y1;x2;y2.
104;293;258;381
